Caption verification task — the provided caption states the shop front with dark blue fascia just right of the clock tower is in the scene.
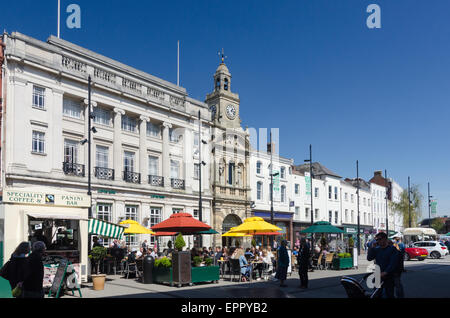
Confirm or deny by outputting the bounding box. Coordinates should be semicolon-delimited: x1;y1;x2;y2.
253;211;295;248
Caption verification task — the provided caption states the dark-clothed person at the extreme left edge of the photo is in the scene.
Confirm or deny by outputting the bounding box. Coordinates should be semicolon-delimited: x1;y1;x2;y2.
0;242;30;297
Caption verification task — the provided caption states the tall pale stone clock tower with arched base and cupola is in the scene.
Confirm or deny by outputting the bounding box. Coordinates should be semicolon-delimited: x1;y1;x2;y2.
205;53;251;246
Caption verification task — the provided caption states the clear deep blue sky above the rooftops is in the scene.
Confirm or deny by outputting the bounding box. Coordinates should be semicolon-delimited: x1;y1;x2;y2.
0;0;450;216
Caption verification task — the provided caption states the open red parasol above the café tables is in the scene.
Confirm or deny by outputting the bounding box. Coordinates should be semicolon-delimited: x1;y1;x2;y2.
151;213;211;235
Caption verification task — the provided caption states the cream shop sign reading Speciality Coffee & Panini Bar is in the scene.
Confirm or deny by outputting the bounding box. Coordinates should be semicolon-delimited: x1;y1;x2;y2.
3;190;90;207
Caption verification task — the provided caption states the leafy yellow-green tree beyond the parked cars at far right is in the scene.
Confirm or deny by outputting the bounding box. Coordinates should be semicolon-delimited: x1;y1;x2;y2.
390;185;423;228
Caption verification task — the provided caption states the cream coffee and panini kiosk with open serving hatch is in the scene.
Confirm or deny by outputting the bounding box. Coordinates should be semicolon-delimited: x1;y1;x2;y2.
3;188;91;287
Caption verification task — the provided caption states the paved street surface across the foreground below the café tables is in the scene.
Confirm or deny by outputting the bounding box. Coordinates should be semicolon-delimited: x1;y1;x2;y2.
64;254;450;299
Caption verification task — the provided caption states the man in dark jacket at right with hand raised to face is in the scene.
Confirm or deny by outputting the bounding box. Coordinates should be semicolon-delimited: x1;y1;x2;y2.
367;232;400;298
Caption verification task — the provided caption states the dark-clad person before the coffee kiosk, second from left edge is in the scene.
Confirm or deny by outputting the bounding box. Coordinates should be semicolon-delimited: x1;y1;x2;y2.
23;241;46;298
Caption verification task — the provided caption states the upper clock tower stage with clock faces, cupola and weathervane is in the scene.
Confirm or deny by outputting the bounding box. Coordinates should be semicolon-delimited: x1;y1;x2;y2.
205;54;241;128
